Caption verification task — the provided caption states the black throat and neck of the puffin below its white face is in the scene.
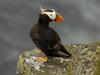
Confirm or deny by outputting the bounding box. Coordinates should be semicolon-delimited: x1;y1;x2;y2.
38;14;50;27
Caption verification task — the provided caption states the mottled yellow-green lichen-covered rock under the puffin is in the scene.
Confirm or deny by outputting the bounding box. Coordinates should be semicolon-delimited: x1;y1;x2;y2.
17;43;100;75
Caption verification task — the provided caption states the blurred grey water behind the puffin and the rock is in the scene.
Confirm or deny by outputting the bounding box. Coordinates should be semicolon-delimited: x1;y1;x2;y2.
0;0;100;75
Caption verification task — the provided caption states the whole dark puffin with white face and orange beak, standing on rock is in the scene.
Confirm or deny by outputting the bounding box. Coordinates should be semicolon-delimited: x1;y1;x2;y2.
30;7;71;58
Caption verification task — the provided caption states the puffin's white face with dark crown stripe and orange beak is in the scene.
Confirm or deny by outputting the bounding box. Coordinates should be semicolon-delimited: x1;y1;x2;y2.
40;7;64;23
